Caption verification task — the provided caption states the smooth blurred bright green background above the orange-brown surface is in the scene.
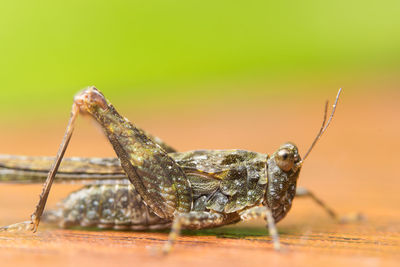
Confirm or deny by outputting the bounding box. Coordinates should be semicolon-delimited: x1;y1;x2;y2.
0;0;400;121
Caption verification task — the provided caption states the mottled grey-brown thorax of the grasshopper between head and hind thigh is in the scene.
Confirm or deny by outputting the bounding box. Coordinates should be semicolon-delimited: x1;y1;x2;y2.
170;150;268;216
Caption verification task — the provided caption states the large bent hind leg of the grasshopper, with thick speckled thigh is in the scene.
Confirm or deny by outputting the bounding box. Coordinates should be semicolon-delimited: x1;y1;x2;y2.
2;87;192;232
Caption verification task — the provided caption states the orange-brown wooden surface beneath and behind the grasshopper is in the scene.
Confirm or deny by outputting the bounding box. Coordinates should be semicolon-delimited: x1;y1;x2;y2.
0;93;400;267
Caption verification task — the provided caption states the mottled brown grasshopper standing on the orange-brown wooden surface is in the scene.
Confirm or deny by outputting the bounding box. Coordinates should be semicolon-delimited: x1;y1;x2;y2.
0;87;341;252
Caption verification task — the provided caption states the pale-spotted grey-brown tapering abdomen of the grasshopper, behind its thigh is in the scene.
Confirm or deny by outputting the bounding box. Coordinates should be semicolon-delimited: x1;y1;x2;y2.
45;184;171;230
